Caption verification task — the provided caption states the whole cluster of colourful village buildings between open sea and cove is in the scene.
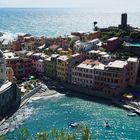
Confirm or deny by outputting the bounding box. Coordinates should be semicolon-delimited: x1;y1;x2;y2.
1;31;139;97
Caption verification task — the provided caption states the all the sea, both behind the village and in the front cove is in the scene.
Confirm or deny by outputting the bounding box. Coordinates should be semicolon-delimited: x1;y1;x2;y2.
0;8;140;140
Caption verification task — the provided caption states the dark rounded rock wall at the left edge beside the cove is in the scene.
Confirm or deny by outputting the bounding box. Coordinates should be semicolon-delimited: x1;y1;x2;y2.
0;83;21;120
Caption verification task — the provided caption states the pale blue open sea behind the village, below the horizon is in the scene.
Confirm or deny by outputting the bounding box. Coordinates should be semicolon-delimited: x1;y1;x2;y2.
0;8;140;37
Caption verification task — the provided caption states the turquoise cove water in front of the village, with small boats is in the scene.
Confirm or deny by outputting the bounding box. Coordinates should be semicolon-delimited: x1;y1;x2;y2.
8;95;140;140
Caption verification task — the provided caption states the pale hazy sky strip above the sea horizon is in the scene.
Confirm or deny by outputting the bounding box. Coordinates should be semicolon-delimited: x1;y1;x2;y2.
0;0;140;12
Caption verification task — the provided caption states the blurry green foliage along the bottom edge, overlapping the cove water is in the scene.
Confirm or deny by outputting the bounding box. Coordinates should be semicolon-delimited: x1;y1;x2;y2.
0;125;91;140
